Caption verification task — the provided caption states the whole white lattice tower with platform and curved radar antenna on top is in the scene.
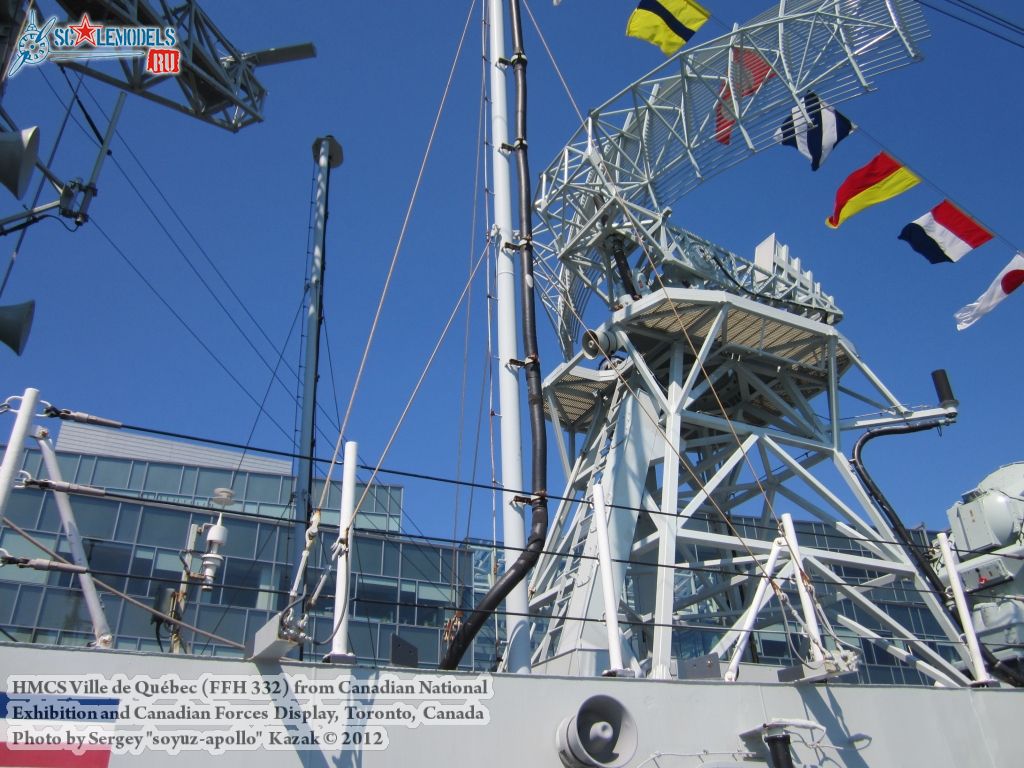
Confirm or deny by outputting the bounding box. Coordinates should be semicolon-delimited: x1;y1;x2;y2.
530;0;970;686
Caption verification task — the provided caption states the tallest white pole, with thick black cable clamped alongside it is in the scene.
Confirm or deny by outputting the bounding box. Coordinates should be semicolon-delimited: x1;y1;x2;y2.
487;0;530;673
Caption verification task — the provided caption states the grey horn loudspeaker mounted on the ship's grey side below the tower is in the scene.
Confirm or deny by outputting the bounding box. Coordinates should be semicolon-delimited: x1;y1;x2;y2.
555;696;637;768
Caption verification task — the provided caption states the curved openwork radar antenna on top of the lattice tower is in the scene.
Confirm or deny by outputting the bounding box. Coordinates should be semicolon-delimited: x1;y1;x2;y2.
535;0;929;359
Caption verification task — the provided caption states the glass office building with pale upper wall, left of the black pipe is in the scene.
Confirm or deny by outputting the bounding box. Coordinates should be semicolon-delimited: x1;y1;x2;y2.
0;423;496;670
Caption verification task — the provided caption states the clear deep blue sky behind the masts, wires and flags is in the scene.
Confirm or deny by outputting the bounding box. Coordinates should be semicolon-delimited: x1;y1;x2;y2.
0;0;1024;536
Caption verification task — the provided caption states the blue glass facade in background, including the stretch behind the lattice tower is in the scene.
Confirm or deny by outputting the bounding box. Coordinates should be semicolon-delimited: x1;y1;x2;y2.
0;434;956;684
